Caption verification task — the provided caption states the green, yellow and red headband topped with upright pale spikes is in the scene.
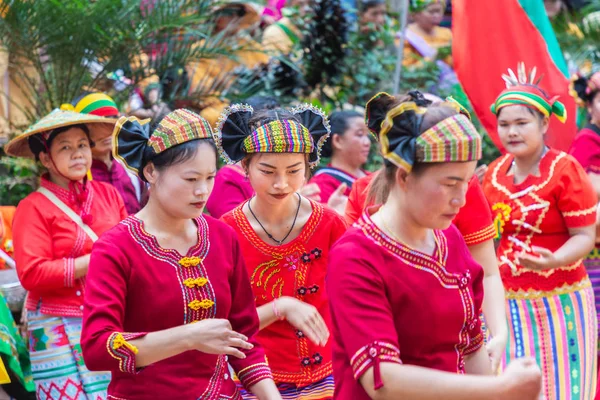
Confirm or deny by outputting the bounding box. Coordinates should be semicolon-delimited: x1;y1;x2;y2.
491;63;567;123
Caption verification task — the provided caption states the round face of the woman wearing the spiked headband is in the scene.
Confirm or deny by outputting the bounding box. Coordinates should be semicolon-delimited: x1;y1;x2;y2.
498;105;548;158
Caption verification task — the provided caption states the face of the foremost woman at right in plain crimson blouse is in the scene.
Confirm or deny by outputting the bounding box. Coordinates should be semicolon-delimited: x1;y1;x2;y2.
397;161;477;229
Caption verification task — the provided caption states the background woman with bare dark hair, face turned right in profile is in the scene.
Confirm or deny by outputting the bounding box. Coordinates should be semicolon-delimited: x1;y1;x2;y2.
310;111;371;204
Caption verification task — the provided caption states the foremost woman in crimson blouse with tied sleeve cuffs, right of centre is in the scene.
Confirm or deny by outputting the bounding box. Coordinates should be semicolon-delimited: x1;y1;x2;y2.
327;92;539;400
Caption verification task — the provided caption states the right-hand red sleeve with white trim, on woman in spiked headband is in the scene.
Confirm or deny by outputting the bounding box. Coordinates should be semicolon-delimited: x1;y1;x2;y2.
558;156;598;228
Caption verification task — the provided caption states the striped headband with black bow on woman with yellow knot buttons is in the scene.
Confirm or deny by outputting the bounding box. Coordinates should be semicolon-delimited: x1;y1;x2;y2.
113;109;213;181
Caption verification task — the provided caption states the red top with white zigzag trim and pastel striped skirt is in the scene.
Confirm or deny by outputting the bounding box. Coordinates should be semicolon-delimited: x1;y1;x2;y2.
483;149;598;400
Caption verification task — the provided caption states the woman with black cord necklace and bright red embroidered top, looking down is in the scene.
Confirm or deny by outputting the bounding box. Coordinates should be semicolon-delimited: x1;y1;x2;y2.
217;105;345;400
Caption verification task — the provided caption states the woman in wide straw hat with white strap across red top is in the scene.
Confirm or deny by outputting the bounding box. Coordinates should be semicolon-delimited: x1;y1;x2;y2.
5;110;127;400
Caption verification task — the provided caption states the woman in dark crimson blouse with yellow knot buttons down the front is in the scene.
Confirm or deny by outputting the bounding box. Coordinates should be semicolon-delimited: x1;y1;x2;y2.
81;110;280;400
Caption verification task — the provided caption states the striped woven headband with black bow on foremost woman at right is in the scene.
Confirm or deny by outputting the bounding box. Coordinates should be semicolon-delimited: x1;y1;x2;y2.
367;92;482;172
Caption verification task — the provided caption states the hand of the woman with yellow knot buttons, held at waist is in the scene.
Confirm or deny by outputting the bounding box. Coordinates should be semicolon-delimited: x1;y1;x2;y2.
185;319;254;358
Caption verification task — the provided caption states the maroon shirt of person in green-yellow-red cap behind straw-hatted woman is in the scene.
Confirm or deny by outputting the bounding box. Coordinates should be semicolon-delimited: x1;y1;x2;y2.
91;160;144;214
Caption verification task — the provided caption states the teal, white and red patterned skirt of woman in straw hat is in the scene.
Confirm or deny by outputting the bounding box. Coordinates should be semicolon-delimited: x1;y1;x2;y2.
27;311;110;400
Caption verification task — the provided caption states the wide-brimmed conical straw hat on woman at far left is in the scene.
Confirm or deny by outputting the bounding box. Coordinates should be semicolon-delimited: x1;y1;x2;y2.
4;109;116;158
